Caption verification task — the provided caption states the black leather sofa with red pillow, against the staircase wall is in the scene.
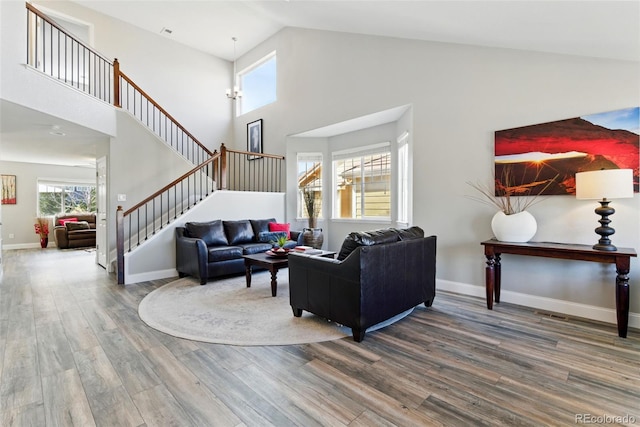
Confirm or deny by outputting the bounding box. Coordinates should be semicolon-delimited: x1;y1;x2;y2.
176;218;302;285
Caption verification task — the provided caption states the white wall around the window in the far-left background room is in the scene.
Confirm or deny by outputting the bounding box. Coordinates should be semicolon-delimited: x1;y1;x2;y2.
0;161;96;249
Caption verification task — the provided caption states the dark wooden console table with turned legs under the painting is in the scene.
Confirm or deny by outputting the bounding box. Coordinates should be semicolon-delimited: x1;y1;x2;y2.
481;239;637;338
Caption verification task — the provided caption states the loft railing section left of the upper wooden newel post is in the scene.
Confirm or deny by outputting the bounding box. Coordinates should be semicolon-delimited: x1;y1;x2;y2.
27;3;113;103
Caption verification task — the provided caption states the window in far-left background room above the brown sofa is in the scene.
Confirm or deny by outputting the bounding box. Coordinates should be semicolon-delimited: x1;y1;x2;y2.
38;180;97;216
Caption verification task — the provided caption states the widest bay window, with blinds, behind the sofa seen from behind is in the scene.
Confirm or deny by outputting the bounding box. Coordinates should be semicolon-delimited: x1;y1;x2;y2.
333;143;391;219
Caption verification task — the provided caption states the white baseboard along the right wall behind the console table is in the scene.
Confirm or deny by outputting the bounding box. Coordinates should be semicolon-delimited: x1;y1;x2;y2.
436;279;640;329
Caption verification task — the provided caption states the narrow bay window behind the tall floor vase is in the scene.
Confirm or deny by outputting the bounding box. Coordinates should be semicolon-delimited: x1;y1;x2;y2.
297;153;322;218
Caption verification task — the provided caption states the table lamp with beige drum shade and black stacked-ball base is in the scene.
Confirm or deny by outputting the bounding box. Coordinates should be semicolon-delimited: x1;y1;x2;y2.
576;169;633;251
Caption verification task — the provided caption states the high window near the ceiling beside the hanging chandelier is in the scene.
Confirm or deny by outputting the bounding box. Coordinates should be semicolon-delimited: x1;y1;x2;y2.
238;52;277;114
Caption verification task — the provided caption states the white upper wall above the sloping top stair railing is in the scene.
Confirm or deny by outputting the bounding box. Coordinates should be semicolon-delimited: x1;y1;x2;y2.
35;1;232;151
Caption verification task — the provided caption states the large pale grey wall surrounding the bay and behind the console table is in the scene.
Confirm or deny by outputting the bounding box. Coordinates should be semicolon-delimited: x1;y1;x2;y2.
235;29;640;322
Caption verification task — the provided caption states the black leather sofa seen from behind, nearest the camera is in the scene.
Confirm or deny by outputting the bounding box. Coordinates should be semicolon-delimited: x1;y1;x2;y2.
289;227;436;342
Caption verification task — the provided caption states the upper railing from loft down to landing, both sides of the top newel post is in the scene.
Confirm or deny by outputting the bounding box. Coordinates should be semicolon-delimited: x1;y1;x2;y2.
26;3;213;165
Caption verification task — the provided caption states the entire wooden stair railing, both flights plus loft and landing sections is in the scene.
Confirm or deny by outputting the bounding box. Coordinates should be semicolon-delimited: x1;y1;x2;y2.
26;3;284;284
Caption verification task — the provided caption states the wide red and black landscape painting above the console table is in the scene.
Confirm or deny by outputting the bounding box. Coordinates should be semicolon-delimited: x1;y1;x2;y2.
495;107;640;195
